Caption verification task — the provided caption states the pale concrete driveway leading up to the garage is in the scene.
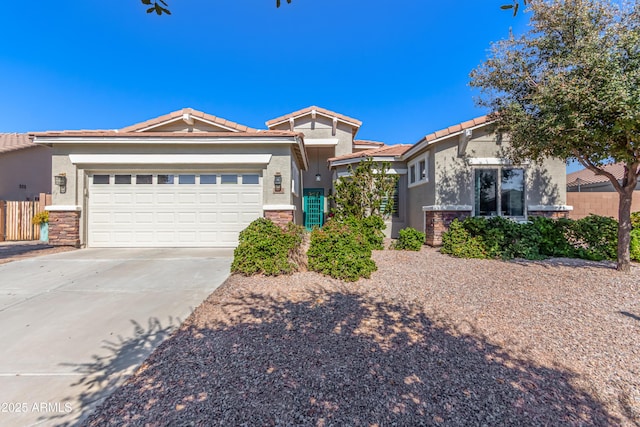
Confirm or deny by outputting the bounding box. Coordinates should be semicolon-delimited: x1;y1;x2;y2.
0;249;233;426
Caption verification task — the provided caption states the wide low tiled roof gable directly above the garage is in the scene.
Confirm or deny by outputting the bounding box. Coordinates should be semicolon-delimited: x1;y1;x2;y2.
120;108;255;133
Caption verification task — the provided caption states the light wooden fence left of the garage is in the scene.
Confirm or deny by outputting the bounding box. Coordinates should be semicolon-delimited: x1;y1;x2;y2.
0;193;51;242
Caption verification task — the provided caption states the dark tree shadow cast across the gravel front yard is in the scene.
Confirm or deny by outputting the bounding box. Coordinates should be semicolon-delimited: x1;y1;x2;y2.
86;289;620;426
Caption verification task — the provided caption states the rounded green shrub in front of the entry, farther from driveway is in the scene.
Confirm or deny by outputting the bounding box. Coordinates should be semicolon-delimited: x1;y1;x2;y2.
307;219;377;282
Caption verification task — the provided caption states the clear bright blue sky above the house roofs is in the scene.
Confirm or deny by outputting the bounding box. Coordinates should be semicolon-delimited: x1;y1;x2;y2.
0;0;528;144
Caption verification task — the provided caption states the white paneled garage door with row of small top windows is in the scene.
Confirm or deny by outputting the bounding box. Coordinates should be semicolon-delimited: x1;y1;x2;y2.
87;172;262;247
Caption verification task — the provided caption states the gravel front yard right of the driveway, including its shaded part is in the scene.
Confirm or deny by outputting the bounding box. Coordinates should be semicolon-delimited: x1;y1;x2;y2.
85;247;640;426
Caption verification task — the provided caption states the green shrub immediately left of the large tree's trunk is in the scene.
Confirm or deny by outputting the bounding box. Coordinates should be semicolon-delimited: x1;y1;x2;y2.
569;215;618;261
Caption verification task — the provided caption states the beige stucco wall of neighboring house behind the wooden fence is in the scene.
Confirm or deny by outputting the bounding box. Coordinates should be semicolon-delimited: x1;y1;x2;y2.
0;147;51;200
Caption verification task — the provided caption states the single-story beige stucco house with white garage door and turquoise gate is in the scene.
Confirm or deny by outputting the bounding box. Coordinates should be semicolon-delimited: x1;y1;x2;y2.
31;106;570;247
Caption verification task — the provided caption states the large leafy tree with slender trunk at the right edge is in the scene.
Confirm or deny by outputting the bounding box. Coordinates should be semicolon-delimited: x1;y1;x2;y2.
471;0;640;271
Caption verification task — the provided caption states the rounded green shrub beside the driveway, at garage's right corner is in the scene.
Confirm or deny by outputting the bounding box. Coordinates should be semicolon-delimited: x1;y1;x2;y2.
231;218;304;276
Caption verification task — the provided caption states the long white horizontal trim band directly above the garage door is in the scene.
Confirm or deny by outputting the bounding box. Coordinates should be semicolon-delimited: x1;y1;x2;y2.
69;154;271;165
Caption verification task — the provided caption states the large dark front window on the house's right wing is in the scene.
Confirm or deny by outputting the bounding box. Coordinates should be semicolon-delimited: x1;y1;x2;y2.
475;168;524;217
